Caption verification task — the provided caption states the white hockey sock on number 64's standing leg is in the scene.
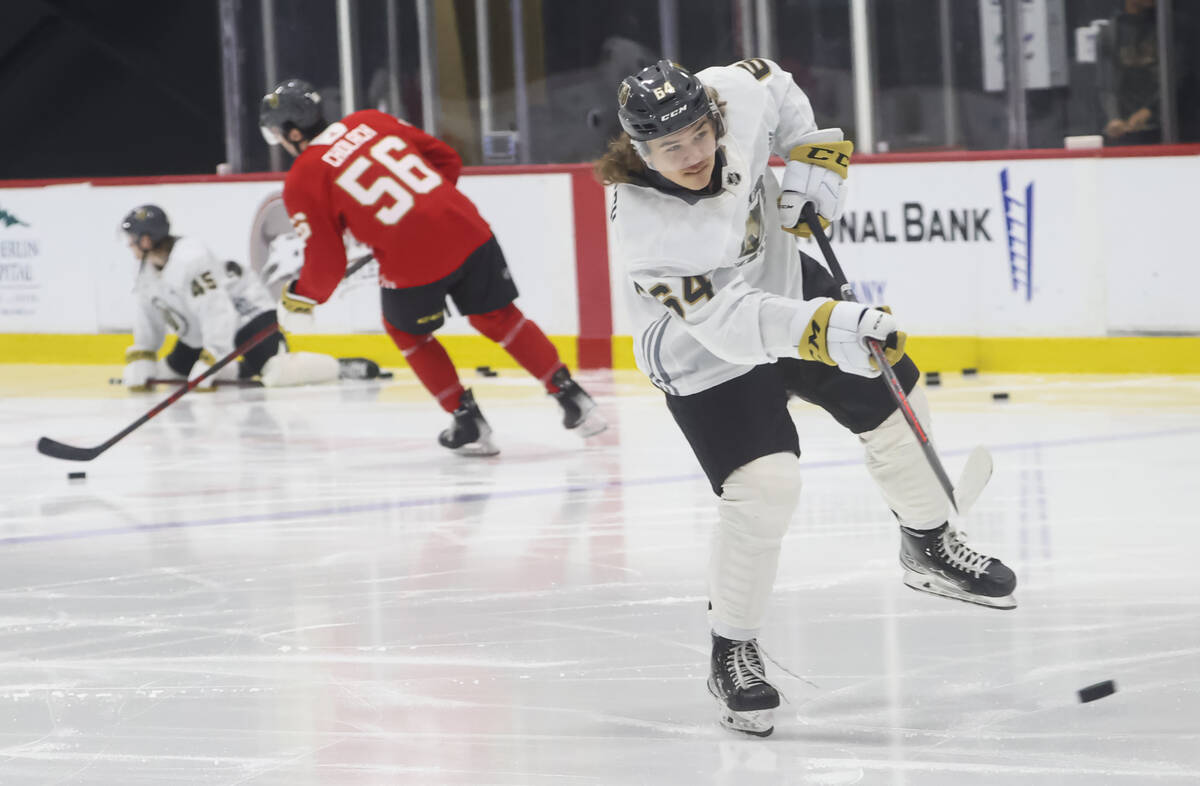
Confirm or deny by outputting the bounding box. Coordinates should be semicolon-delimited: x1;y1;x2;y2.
708;452;800;640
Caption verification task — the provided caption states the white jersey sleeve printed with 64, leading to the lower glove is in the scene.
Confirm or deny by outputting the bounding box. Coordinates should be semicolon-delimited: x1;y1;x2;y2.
630;263;828;365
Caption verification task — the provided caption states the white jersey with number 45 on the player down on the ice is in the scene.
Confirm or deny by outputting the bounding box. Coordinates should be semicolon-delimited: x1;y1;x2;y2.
133;238;275;358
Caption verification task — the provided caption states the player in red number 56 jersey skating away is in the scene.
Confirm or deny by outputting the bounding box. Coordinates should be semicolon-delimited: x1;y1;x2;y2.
259;79;605;456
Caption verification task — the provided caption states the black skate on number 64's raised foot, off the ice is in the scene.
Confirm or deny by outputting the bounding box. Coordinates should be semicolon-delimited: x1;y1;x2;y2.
900;523;1016;608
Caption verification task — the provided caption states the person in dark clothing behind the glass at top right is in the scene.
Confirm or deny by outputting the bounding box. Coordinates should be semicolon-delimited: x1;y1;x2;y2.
1098;0;1163;145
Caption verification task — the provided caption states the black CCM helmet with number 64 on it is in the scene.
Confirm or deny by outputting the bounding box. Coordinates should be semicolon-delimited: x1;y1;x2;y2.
617;60;725;142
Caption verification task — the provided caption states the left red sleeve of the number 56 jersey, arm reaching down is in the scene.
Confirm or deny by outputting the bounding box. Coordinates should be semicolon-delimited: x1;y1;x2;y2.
283;158;347;302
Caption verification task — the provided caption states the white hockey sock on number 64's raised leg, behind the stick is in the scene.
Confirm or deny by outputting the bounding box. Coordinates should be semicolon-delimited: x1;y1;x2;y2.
858;388;950;529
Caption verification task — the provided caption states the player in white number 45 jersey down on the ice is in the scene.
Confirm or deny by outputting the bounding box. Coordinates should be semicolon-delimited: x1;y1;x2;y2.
121;205;340;390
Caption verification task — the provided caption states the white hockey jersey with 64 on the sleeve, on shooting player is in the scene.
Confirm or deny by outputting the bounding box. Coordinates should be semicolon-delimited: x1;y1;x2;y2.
610;58;827;396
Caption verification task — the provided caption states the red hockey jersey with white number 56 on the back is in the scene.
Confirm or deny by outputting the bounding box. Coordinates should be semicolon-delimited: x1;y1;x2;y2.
283;109;492;302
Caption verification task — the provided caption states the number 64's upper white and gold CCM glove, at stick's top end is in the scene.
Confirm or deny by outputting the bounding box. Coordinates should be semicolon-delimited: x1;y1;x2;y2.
779;128;854;238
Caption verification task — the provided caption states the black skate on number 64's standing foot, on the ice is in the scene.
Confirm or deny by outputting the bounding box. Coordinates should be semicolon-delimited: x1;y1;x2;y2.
708;634;779;737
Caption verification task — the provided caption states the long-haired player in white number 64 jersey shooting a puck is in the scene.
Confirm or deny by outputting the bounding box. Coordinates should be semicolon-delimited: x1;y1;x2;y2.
596;58;1016;736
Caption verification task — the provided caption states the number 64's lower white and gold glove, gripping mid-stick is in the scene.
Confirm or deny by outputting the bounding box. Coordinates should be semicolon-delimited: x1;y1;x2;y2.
799;300;908;377
